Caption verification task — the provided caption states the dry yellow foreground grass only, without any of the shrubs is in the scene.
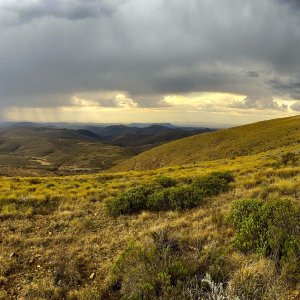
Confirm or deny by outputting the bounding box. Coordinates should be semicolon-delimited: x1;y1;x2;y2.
0;147;300;299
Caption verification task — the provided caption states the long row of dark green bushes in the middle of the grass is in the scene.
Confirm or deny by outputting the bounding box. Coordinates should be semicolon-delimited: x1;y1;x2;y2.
106;172;233;216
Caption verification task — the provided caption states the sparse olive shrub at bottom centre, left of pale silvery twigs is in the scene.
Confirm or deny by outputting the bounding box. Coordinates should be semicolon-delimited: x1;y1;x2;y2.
107;230;200;299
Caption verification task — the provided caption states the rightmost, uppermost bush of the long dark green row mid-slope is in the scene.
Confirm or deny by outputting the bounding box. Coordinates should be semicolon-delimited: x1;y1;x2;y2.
192;172;233;197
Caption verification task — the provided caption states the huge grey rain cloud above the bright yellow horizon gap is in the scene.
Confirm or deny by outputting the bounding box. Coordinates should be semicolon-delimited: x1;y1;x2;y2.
0;0;300;109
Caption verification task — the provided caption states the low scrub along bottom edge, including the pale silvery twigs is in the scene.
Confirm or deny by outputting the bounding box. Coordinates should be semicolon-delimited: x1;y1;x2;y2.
103;229;239;300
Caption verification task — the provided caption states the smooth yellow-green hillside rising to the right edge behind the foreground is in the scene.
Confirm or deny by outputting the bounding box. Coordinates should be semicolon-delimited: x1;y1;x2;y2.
112;116;300;171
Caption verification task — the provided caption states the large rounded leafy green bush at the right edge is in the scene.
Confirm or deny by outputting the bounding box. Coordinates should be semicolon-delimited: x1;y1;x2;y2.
228;199;300;272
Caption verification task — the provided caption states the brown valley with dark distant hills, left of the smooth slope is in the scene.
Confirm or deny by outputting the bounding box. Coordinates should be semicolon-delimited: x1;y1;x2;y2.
0;123;210;175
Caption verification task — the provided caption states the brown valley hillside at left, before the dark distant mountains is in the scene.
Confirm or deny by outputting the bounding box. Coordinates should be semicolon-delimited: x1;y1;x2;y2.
0;127;132;175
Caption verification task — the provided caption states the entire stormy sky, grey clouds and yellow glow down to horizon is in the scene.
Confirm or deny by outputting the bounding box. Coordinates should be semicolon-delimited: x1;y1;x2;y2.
0;0;300;124
